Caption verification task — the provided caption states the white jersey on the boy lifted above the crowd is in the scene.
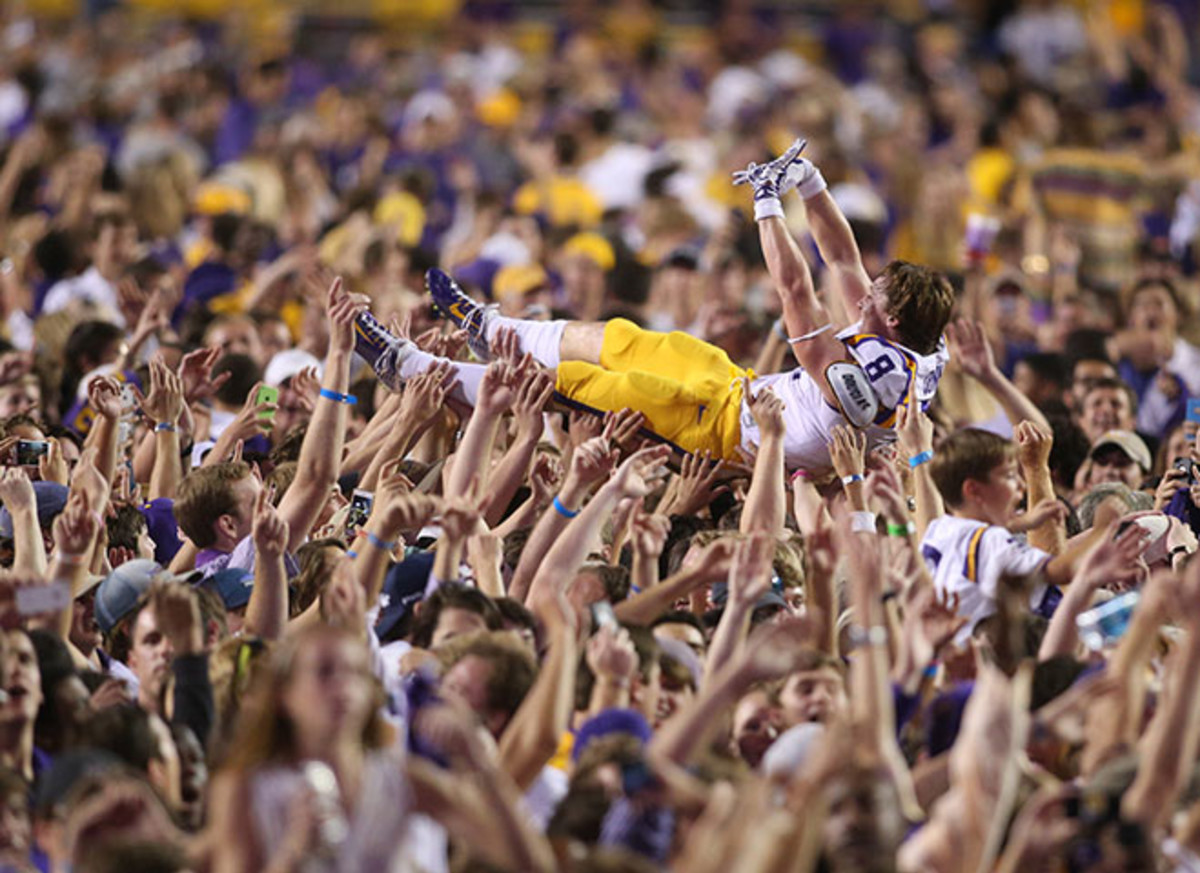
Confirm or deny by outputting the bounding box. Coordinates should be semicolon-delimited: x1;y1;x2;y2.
920;516;1050;643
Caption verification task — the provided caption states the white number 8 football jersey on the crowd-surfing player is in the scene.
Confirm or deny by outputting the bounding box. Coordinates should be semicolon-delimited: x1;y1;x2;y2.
742;321;949;474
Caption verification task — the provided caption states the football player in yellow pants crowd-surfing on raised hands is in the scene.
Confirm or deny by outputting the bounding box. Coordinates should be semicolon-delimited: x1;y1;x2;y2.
359;140;953;474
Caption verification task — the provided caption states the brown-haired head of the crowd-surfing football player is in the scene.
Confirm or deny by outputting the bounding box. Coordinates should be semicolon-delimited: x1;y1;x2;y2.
863;260;954;355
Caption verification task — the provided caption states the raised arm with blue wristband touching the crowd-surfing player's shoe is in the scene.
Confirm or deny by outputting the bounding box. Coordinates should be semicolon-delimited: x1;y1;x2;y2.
280;278;366;552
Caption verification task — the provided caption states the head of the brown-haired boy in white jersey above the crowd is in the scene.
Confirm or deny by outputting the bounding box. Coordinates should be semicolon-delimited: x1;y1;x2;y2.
929;428;1025;525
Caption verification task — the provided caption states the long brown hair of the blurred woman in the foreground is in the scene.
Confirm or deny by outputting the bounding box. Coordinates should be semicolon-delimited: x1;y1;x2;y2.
216;624;388;771
